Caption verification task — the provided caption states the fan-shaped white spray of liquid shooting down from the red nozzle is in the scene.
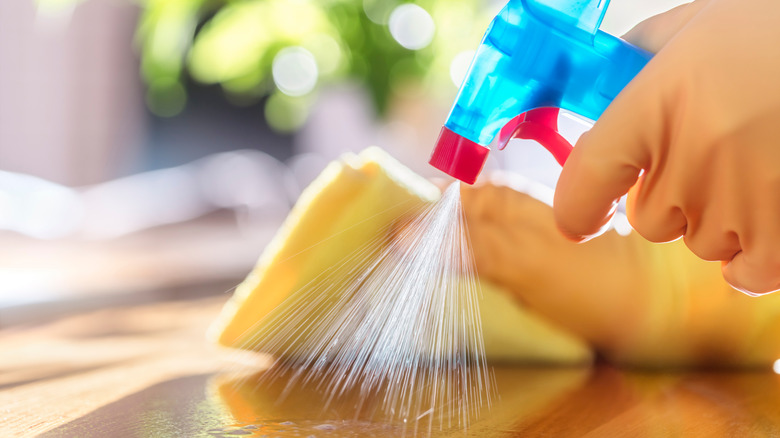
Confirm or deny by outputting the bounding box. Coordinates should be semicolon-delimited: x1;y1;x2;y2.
225;183;493;432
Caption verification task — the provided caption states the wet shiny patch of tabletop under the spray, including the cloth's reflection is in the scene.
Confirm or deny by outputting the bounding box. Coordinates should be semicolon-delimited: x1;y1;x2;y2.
38;369;590;438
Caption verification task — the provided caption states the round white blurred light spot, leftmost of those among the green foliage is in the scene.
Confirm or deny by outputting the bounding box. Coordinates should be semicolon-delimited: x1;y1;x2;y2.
271;47;319;96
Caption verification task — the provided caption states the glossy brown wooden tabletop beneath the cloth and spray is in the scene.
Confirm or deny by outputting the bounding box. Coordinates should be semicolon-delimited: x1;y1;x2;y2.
6;293;780;437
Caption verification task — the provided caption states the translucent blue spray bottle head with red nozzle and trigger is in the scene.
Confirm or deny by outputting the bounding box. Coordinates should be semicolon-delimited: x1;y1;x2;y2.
430;0;652;184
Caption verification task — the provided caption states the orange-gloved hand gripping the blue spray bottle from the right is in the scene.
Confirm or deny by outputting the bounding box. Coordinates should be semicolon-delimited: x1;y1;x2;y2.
554;0;780;294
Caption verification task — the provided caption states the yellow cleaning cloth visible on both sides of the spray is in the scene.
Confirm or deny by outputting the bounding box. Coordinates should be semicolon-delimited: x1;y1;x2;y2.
208;147;591;364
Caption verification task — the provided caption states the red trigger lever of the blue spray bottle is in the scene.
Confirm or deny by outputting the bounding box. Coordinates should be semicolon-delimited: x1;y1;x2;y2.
498;107;573;166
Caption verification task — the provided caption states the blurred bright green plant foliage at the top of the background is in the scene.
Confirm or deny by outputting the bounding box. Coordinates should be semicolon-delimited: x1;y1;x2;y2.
44;0;491;131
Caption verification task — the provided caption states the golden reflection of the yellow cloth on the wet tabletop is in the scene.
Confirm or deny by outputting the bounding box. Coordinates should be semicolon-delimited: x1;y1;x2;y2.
211;367;590;436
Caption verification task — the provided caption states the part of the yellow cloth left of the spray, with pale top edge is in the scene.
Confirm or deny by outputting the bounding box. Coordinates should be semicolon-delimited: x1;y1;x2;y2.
208;147;441;348
